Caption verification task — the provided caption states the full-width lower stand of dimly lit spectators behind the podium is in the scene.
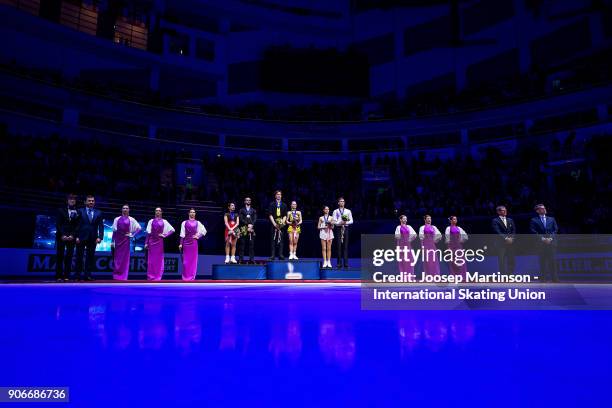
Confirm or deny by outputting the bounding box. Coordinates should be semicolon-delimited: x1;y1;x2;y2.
0;124;612;232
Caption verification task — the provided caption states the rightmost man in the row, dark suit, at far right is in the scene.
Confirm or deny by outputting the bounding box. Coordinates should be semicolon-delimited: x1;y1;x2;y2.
529;204;559;282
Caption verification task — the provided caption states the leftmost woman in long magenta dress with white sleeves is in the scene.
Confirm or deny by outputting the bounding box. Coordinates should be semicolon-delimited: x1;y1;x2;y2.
111;204;140;280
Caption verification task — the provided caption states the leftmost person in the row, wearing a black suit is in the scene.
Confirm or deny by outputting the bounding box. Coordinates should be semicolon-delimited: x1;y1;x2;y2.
55;194;81;282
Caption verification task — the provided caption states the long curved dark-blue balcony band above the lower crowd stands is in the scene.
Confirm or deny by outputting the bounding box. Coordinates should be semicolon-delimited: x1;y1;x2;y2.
0;61;612;154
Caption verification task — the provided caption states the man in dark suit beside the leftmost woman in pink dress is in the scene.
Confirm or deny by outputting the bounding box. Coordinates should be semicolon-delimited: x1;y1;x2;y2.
76;195;104;281
